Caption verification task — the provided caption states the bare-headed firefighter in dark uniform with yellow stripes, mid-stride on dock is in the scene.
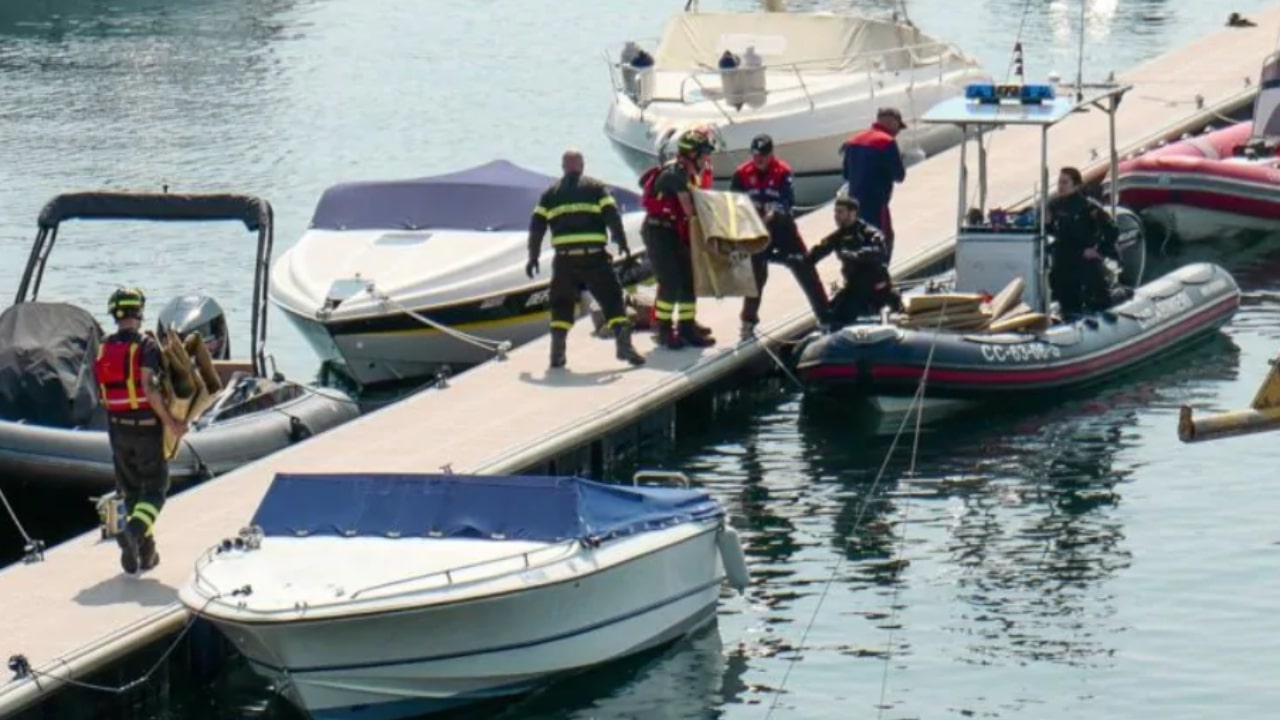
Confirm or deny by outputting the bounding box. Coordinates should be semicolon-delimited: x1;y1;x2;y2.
525;150;644;368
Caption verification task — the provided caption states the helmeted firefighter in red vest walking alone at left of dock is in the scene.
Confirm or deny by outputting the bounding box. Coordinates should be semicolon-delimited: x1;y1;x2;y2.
93;288;187;574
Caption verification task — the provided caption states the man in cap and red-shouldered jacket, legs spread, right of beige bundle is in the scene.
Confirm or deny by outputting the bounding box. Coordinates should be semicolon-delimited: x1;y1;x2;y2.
730;135;827;338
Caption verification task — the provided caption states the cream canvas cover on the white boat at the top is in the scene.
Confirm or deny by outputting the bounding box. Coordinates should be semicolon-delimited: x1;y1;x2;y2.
654;13;955;73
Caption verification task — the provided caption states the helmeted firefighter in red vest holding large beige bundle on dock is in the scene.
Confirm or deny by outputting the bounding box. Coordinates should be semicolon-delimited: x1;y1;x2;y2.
640;131;716;350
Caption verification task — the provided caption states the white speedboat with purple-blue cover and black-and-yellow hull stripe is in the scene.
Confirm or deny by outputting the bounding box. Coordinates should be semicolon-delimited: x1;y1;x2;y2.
271;160;650;387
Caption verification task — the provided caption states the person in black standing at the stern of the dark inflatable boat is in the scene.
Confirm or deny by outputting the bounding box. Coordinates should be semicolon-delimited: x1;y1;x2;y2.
1046;168;1120;318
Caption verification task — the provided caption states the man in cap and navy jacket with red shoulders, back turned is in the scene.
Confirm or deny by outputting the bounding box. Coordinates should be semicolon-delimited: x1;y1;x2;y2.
840;108;906;263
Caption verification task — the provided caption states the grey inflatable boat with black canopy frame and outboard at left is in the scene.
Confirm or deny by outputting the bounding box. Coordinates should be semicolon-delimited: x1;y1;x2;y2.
0;192;360;492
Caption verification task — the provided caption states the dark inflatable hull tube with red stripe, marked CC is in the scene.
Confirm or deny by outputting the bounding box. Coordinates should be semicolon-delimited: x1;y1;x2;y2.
796;263;1240;400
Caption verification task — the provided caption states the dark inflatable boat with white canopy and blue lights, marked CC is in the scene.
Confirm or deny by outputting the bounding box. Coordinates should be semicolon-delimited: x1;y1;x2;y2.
795;78;1240;416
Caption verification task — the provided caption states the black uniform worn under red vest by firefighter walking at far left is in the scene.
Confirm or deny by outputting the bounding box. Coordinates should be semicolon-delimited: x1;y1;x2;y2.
101;329;169;573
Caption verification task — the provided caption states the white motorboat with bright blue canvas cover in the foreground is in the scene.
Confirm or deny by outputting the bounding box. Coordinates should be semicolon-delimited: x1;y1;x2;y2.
179;473;748;720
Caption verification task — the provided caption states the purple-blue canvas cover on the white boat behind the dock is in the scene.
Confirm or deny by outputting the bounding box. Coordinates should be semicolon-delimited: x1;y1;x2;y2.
310;160;640;231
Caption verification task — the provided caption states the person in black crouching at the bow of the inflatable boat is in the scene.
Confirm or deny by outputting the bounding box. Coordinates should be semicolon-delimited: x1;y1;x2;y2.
805;196;902;324
